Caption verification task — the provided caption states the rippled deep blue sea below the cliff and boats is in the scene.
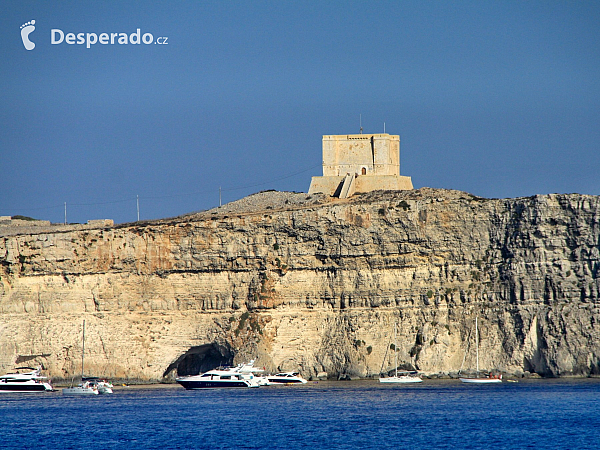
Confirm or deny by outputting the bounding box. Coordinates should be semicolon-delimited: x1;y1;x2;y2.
0;379;600;450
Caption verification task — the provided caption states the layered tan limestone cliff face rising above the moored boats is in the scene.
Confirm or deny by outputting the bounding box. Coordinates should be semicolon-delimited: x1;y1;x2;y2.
0;188;600;380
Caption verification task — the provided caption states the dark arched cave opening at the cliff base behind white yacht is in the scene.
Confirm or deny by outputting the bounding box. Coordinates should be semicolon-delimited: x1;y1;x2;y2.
163;343;233;377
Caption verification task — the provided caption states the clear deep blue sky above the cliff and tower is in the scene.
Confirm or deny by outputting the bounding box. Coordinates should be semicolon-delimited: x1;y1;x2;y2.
0;0;600;223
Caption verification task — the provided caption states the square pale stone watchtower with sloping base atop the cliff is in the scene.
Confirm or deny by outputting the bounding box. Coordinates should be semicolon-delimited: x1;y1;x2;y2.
308;133;413;198
